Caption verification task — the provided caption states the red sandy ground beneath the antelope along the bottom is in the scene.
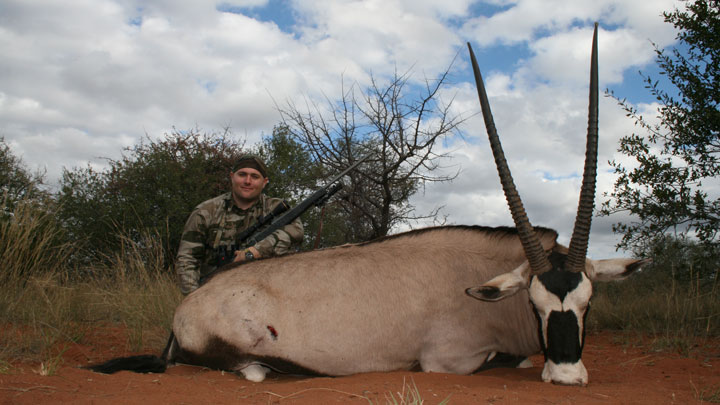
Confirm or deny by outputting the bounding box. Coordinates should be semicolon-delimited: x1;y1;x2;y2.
0;327;720;404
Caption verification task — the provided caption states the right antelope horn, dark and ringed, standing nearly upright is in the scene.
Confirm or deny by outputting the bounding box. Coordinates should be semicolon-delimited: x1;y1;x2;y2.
565;23;598;272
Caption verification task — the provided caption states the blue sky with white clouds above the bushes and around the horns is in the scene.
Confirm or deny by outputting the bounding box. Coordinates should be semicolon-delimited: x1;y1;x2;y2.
0;0;682;257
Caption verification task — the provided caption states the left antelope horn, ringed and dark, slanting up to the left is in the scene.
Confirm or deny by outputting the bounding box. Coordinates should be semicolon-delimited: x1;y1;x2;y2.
468;42;552;274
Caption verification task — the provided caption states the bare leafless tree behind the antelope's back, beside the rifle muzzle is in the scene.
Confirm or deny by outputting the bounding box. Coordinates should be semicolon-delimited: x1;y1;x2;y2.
278;64;464;241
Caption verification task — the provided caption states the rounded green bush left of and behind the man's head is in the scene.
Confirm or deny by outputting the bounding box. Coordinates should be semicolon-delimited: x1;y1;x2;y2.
56;130;250;267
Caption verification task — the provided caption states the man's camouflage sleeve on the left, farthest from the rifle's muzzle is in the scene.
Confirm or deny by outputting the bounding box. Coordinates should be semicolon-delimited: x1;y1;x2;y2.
175;209;207;295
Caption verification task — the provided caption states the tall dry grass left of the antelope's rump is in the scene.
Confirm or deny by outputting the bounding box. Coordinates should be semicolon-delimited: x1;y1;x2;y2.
0;198;181;362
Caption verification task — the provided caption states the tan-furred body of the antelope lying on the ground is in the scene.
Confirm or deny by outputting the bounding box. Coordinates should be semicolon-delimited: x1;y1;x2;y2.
173;227;557;375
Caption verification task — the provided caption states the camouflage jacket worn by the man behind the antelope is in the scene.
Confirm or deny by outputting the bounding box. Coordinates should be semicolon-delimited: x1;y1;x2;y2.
175;193;303;294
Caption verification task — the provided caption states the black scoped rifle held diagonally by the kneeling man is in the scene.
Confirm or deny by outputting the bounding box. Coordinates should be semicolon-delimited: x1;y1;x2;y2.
211;155;370;272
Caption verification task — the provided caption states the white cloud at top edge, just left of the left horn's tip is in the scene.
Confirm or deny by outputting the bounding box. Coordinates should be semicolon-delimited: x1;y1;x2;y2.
290;0;458;74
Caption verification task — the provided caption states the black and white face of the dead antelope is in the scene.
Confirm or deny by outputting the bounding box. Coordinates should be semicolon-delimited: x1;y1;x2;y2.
529;256;592;385
